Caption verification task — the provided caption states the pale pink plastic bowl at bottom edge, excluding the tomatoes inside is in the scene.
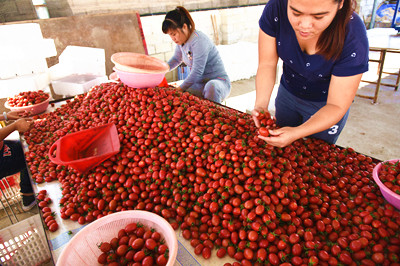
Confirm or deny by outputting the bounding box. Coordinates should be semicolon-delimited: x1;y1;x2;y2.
57;210;178;266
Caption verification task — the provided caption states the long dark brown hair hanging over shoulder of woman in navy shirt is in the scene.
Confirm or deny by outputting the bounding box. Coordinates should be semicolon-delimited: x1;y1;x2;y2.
317;0;357;60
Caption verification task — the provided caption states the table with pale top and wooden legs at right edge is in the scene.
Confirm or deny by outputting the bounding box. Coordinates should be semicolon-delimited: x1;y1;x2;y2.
357;28;400;103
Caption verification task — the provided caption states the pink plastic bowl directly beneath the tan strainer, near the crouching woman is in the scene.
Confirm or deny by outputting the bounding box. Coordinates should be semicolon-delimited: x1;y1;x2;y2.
114;67;165;89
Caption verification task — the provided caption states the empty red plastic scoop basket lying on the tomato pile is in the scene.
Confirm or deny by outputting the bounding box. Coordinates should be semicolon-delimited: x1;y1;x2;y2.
49;123;120;173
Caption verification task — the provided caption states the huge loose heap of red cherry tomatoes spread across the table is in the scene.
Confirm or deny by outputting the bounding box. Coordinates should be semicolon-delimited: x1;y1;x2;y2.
25;83;400;265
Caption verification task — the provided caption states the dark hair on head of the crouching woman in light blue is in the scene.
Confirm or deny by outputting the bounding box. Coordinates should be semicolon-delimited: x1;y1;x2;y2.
162;6;195;34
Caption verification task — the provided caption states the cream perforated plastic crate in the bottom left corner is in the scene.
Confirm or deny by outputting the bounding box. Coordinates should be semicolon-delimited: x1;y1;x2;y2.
0;214;51;266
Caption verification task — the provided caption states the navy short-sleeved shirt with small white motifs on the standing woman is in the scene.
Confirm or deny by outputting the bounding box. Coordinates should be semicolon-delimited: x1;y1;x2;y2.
259;0;369;101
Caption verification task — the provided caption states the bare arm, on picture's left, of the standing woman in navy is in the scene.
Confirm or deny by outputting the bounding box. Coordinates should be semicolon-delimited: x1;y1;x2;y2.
252;29;279;127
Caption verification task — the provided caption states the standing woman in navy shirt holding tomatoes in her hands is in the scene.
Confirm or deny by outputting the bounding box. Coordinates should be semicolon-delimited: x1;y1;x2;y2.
252;0;369;147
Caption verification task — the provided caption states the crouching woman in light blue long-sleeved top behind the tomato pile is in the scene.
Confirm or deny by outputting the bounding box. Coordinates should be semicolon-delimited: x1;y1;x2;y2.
162;6;231;103
